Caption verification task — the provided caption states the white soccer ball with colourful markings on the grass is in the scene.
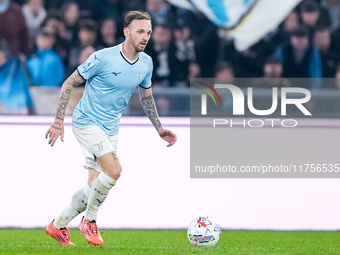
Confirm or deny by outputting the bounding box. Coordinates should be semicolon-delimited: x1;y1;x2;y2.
188;217;222;247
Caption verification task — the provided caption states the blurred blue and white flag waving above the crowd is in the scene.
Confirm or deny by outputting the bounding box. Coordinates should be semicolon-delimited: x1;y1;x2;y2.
168;0;301;51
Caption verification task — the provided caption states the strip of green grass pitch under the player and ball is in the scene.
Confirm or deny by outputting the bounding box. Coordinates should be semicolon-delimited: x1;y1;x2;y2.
0;229;340;255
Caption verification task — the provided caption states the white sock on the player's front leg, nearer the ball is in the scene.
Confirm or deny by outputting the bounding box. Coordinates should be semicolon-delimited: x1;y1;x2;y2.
83;173;116;222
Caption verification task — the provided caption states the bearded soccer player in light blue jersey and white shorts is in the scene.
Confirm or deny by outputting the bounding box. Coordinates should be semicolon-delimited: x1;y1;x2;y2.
46;11;177;245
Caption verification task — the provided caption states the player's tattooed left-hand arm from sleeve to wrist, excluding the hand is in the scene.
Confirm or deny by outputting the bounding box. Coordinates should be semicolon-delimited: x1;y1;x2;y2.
55;70;85;120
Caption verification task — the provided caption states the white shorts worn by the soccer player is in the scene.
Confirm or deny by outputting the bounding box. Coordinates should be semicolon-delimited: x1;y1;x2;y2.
72;126;118;172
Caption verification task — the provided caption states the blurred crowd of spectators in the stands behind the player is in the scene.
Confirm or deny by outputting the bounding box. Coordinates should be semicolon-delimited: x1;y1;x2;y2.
0;0;340;115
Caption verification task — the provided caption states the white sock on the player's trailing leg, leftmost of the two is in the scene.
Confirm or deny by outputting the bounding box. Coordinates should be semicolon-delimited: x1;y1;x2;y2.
53;183;91;229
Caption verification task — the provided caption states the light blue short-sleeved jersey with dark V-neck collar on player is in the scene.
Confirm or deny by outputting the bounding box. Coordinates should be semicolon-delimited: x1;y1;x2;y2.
72;44;153;135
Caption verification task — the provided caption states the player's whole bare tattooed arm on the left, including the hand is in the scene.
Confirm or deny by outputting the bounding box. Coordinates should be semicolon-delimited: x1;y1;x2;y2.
45;70;85;146
